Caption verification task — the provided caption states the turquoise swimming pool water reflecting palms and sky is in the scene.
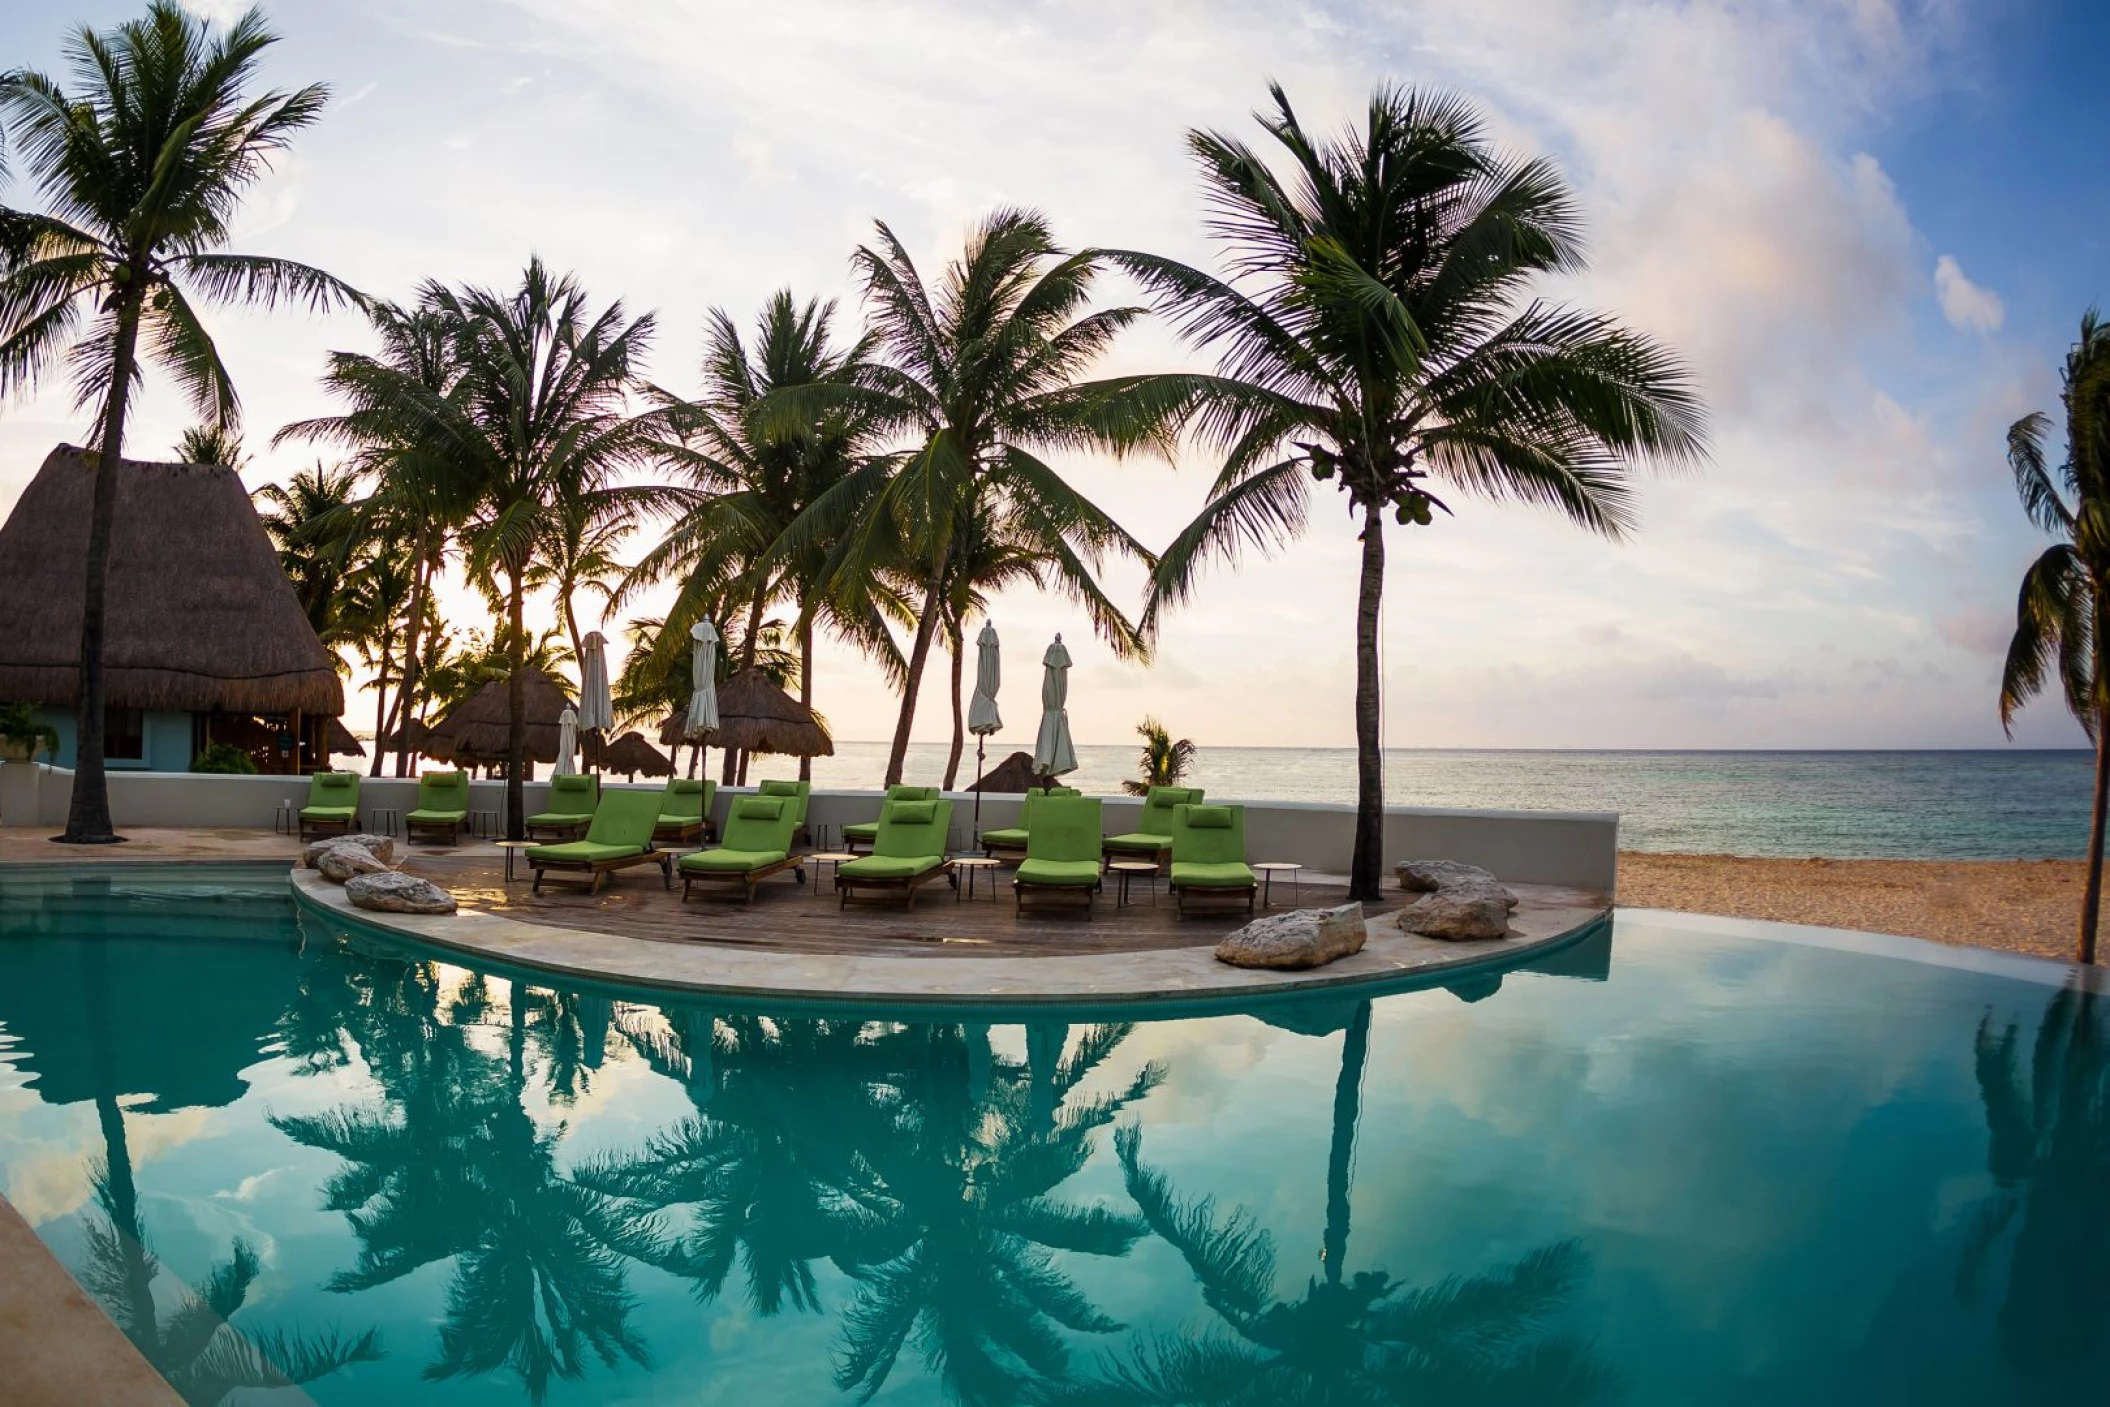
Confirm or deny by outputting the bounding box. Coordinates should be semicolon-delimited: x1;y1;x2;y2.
0;869;2110;1407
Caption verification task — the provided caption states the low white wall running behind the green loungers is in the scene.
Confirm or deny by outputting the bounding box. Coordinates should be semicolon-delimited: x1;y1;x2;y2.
0;762;1618;892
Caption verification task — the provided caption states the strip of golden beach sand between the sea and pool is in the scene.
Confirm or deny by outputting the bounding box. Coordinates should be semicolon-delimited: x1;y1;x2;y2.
1618;850;2087;960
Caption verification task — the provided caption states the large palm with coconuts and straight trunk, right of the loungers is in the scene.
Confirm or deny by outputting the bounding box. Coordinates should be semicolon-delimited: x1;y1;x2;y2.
1106;86;1705;901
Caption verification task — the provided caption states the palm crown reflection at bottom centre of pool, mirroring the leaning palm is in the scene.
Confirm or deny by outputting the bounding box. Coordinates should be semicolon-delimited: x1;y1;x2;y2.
836;1025;1163;1403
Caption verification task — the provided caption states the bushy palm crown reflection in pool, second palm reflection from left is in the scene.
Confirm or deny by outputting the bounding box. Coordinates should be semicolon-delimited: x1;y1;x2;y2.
272;968;646;1401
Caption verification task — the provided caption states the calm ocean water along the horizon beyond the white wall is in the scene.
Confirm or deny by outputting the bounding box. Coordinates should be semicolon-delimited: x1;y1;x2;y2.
801;743;2093;861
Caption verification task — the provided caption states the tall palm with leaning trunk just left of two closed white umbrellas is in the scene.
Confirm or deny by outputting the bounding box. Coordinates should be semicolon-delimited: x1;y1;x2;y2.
789;209;1163;785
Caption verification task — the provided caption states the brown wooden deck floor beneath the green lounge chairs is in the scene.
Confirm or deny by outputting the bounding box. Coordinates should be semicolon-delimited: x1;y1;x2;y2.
397;846;1397;958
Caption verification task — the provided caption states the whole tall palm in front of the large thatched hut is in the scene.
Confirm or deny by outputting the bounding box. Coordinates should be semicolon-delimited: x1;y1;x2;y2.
0;0;359;844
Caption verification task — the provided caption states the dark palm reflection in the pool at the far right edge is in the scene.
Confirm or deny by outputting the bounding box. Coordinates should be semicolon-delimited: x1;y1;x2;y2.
1956;987;2110;1384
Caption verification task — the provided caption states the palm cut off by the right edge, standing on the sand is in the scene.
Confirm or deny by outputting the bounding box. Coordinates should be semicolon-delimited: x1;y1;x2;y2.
2000;308;2110;962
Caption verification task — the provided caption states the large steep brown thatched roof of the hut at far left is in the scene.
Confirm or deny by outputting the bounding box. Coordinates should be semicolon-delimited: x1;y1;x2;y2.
0;445;344;717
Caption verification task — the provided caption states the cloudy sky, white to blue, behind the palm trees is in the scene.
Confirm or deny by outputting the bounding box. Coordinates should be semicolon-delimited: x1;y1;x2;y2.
0;0;2110;749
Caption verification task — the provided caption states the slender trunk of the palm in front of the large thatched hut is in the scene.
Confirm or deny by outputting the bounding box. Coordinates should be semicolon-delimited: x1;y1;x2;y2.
55;280;146;846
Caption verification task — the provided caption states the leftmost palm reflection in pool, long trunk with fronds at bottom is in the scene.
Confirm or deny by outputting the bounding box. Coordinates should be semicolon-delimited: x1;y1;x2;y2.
80;943;382;1407
